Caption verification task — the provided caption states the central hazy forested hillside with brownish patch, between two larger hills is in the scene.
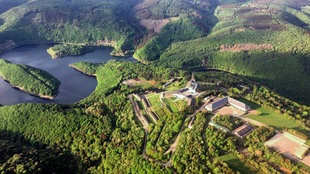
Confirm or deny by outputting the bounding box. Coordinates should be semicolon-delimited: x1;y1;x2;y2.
134;0;217;63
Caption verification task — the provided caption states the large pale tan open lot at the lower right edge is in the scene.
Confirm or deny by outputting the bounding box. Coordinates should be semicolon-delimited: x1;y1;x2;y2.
265;132;309;162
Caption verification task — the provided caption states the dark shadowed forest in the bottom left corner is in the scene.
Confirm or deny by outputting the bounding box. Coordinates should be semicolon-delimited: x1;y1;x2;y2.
0;130;79;174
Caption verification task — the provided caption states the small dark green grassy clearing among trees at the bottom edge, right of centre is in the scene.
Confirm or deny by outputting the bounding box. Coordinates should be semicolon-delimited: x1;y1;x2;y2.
219;153;258;174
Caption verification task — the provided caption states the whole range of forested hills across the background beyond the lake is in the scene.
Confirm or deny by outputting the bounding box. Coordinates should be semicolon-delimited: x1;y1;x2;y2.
0;0;310;104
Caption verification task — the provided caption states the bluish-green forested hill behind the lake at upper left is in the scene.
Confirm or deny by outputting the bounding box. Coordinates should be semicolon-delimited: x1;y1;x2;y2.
0;0;142;55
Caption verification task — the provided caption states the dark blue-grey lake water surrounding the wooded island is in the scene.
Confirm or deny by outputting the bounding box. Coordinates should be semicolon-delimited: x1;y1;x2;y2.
0;44;134;105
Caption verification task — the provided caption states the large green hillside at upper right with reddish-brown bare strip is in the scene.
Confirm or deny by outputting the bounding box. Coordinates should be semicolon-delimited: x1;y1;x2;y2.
156;0;310;104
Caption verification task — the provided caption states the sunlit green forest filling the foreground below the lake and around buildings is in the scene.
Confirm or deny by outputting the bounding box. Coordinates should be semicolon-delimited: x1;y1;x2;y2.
0;61;309;173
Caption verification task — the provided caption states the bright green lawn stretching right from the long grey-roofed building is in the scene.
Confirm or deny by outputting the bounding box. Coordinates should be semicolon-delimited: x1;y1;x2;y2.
241;99;307;132
